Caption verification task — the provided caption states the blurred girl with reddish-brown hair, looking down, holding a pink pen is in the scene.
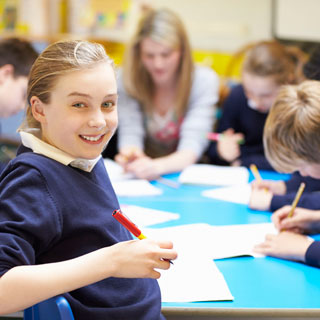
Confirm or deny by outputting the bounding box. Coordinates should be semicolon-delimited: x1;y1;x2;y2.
208;41;304;170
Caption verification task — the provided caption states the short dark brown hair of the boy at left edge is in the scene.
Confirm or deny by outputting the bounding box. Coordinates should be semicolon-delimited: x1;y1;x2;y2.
0;38;38;77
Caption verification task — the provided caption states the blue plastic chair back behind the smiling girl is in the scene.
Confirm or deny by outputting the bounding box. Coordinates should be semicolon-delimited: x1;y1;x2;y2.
23;296;74;320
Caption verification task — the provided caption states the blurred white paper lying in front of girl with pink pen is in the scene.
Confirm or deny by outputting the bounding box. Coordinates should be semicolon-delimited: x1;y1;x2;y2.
179;164;249;186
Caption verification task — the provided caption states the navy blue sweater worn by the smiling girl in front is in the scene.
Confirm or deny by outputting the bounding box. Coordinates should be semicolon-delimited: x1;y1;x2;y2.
0;147;164;320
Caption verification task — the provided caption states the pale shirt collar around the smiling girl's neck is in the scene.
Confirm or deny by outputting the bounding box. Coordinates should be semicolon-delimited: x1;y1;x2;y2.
19;129;101;172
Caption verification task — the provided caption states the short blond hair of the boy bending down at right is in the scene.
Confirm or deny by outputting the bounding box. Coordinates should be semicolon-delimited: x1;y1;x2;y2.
263;80;320;172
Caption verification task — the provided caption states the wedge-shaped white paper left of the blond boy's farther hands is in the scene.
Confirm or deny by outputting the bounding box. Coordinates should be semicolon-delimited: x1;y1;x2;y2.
202;184;251;205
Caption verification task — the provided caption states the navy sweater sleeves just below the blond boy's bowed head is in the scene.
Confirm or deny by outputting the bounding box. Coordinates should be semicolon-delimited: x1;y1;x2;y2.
270;172;320;211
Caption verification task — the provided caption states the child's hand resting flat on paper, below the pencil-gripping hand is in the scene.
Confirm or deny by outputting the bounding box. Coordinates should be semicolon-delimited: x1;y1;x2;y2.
253;231;313;262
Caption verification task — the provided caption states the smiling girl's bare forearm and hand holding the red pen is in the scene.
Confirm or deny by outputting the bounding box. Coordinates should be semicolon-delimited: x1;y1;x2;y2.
0;239;177;314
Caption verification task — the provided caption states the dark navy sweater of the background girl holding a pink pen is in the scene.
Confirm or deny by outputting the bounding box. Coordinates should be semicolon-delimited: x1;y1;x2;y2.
208;85;273;170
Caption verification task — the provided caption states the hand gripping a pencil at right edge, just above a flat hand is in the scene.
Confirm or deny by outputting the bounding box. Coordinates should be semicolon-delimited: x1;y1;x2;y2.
272;206;320;234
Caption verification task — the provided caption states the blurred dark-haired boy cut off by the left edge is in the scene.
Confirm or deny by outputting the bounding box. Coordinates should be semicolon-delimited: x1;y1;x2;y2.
0;38;38;172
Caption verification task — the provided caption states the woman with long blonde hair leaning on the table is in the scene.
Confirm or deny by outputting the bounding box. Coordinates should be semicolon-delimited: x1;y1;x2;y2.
116;9;219;179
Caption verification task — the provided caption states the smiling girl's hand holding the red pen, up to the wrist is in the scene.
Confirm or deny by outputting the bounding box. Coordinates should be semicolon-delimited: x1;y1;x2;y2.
110;239;177;279
